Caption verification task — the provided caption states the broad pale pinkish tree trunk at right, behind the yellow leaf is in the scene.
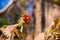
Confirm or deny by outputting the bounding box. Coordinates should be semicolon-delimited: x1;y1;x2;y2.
45;3;60;31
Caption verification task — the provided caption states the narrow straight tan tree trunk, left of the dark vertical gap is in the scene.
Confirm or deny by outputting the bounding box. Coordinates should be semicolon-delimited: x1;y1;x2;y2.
34;0;41;37
